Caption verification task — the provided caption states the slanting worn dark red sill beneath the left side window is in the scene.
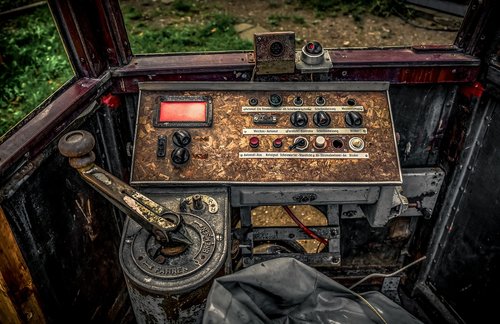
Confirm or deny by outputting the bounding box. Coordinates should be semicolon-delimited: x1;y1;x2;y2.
0;76;107;181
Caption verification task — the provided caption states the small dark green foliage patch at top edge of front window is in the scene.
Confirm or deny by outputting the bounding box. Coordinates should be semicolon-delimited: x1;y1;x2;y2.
300;0;408;21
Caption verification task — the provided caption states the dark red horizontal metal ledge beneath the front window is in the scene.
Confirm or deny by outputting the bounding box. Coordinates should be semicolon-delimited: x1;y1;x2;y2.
112;47;480;93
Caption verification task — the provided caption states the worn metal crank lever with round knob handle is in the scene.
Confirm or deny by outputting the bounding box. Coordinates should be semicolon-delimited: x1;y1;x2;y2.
58;130;192;245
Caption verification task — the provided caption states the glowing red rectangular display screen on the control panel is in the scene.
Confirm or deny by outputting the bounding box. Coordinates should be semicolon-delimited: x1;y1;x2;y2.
158;101;207;123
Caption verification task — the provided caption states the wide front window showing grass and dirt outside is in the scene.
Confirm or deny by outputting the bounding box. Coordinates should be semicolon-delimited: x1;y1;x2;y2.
120;0;467;53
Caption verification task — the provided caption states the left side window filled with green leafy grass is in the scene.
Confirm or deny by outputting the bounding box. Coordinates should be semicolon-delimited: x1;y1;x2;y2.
0;0;74;138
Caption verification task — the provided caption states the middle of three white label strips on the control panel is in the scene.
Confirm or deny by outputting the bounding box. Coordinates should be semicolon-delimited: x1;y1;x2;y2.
243;128;368;135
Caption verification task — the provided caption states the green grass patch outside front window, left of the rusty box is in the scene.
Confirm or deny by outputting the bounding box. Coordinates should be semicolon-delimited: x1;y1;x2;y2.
127;14;252;53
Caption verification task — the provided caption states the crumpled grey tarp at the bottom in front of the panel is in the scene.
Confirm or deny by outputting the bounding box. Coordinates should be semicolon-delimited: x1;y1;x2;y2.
203;258;421;324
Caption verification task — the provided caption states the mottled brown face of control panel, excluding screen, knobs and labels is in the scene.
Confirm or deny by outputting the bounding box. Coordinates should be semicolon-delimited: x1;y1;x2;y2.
132;85;400;183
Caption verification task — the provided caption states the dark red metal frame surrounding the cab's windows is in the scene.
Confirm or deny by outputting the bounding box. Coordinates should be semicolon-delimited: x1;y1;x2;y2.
0;0;495;177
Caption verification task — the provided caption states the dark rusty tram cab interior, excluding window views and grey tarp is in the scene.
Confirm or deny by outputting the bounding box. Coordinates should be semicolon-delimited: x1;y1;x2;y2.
0;0;500;323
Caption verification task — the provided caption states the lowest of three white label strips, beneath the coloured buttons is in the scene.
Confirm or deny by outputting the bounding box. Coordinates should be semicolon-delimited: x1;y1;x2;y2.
240;152;370;159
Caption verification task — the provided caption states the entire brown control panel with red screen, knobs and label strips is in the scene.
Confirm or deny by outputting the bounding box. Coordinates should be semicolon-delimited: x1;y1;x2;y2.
131;82;402;185
